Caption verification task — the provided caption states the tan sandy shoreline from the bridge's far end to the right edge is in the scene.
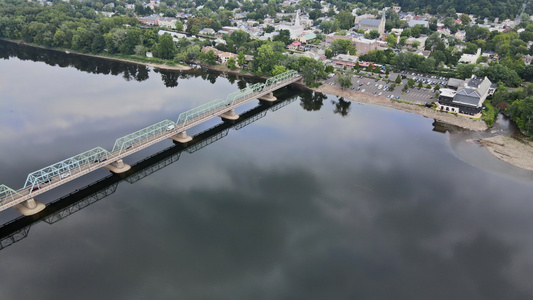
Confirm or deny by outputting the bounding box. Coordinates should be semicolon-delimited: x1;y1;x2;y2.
313;85;533;171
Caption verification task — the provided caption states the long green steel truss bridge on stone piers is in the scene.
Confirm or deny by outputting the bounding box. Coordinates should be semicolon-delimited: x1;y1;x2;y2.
0;71;301;215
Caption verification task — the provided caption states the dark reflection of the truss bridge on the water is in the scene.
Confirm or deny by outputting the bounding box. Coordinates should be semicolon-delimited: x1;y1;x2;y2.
0;96;298;250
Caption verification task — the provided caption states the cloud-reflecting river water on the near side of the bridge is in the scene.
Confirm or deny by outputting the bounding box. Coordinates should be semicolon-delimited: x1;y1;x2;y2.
0;55;533;299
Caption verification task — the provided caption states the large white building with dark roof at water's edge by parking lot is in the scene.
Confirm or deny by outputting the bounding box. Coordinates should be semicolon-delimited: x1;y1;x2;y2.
438;75;496;115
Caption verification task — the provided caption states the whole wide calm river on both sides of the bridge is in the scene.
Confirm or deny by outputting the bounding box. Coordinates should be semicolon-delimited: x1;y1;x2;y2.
0;42;533;300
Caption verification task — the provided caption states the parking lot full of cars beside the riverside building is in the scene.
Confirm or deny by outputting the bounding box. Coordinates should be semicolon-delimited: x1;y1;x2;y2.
324;73;440;104
